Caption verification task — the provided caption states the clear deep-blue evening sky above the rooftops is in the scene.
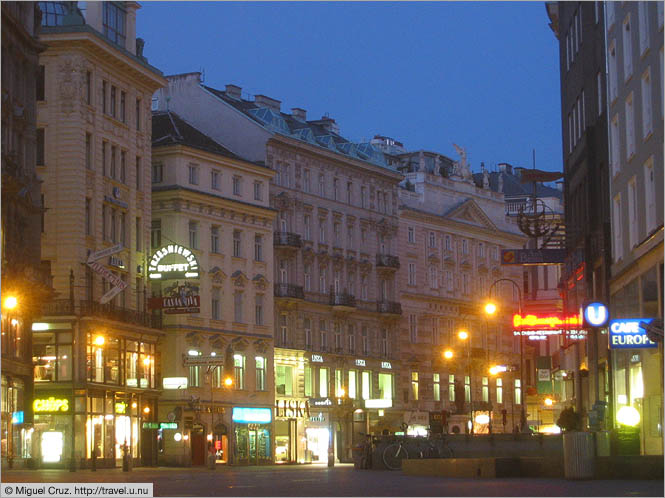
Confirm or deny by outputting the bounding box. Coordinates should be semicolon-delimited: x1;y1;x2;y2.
137;2;562;171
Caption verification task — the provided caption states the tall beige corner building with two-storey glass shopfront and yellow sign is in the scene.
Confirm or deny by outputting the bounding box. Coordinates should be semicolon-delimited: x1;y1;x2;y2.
32;2;165;468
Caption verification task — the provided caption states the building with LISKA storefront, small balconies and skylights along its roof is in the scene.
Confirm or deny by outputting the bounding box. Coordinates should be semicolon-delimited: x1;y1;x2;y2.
157;73;403;462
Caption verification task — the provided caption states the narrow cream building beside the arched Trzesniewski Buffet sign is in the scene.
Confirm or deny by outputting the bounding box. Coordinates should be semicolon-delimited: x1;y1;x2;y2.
149;112;276;465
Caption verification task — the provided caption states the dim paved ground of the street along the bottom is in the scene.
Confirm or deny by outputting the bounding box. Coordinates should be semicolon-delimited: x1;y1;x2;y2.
2;465;664;497
